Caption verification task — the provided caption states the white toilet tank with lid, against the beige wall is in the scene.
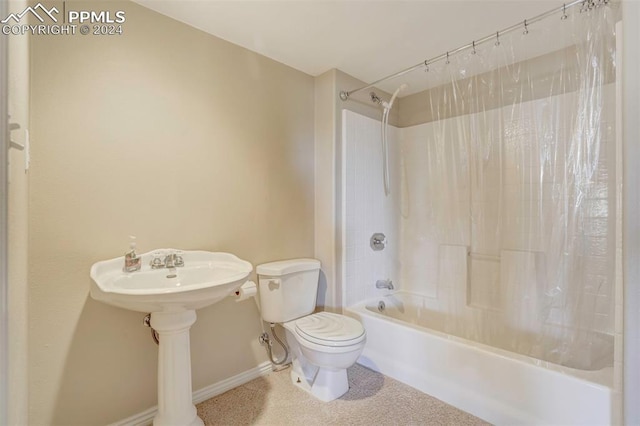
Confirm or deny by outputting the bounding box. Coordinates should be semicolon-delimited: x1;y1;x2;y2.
256;259;320;323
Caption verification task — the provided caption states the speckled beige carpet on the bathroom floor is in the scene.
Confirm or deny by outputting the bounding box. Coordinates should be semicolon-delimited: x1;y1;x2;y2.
197;364;487;426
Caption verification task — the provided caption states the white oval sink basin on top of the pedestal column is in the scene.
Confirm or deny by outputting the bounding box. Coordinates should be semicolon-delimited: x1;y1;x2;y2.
90;249;253;312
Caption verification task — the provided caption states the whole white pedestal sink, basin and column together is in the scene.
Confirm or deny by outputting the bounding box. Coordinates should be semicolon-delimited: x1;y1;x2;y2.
90;249;253;426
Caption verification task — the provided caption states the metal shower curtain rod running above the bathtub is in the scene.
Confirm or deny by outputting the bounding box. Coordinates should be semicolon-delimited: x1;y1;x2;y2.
340;0;610;101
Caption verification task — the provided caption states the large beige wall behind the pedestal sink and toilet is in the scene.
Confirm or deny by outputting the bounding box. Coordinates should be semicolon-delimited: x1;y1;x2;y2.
29;1;314;425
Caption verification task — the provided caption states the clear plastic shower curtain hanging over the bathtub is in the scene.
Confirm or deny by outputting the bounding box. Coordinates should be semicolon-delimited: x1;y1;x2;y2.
400;2;621;370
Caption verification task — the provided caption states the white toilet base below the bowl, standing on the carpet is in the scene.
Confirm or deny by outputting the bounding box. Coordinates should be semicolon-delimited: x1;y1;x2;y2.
291;360;349;402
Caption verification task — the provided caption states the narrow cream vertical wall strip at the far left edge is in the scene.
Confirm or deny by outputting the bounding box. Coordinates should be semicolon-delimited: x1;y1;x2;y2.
8;0;29;425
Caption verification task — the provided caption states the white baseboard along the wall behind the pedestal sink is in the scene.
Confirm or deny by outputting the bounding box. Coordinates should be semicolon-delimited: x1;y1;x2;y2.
109;361;272;426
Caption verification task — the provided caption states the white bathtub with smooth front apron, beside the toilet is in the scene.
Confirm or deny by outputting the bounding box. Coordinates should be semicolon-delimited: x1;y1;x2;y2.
344;292;613;425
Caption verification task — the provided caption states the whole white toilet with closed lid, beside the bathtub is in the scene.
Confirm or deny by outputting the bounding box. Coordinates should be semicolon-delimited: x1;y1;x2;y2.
256;259;366;401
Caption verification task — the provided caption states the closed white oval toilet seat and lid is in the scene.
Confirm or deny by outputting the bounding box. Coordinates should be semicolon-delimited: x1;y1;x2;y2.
295;312;366;347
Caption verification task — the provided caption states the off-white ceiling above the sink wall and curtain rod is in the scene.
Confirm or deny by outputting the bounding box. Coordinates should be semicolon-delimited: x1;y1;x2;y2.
135;0;563;94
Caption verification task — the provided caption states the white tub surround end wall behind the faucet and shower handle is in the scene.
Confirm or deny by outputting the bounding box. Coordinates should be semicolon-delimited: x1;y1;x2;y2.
342;110;401;306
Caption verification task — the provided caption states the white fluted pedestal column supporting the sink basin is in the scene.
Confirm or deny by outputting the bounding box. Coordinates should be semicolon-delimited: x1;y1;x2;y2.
151;311;204;426
